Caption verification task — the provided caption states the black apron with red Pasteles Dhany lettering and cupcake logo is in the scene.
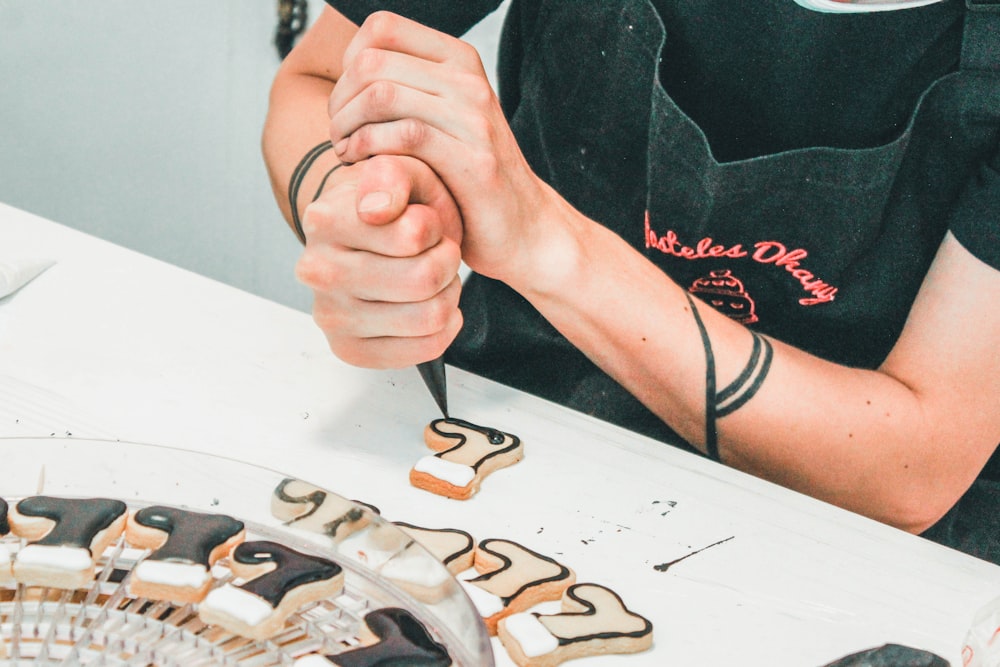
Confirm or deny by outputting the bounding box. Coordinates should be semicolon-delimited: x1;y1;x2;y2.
448;0;1000;472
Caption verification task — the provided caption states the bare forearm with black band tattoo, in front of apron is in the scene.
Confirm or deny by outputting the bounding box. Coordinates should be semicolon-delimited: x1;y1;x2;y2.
506;206;995;531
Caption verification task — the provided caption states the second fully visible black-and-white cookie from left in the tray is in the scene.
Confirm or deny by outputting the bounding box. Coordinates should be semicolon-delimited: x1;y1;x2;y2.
125;505;246;603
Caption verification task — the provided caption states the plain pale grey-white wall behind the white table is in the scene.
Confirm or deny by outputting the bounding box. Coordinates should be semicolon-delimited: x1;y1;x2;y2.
0;0;502;310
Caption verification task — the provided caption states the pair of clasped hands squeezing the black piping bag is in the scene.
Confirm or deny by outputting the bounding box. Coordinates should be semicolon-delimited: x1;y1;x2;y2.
297;12;551;368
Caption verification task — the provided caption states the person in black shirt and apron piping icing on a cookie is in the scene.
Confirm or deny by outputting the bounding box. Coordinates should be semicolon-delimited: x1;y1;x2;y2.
263;0;1000;562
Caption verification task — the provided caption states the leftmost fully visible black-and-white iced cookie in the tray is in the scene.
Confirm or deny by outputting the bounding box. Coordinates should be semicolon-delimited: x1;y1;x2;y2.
9;496;128;588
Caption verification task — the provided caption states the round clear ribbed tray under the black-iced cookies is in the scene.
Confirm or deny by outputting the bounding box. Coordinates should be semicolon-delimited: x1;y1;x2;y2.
0;438;494;667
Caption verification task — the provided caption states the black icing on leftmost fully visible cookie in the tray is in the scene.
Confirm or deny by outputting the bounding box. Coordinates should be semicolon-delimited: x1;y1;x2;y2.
16;496;127;553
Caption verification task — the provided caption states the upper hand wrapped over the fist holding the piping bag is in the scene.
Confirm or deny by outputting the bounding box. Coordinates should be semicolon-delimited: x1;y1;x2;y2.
329;12;562;282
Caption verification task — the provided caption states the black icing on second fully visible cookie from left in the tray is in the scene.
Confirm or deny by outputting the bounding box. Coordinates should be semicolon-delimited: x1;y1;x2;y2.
135;505;243;567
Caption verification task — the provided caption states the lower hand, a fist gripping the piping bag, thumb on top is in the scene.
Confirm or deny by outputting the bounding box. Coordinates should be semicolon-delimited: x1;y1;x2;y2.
296;156;462;368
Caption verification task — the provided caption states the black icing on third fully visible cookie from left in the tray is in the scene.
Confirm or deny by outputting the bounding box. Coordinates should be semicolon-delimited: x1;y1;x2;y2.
233;540;343;608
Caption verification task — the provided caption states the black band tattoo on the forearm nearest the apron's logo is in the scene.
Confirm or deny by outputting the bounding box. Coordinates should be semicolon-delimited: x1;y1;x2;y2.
684;292;774;461
